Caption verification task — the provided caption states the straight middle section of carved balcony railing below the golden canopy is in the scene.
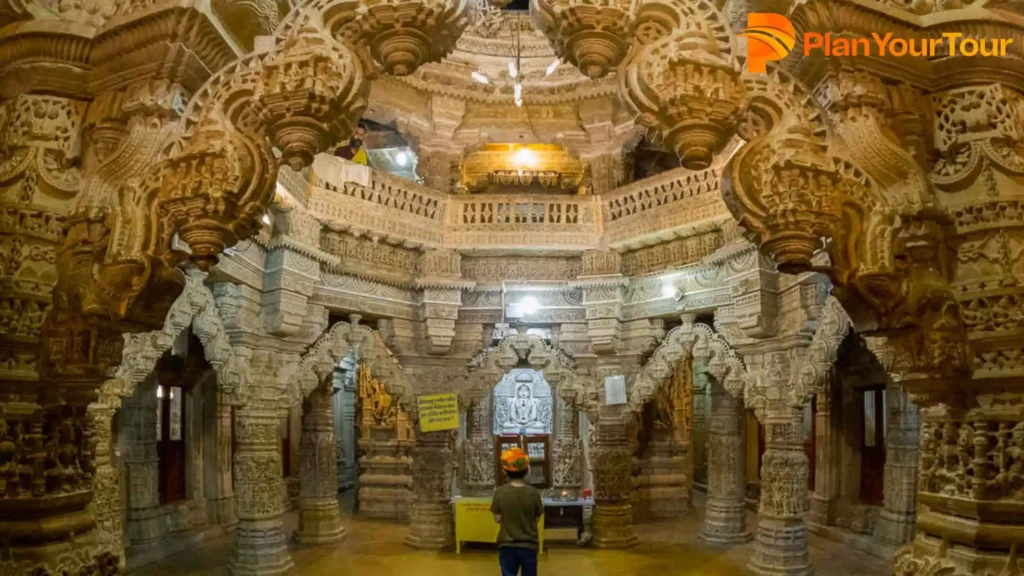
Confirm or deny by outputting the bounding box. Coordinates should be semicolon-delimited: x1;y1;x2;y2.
444;194;600;250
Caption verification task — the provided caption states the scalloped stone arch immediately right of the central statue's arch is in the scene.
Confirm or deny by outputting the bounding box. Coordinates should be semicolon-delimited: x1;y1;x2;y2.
629;324;746;412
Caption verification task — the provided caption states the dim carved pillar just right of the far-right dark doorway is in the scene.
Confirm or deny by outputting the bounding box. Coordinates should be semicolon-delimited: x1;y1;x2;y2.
876;382;920;545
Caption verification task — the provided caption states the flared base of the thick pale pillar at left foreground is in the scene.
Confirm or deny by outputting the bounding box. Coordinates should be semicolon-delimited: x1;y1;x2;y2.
228;517;295;576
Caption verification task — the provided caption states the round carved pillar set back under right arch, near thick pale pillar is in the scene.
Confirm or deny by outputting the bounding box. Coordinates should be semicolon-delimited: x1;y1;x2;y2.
700;381;751;544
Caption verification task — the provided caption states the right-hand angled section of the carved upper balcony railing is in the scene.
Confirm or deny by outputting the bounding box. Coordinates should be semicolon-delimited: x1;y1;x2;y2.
601;166;731;249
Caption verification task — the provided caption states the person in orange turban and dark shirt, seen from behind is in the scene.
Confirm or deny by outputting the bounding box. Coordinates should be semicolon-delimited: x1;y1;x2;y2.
490;447;544;576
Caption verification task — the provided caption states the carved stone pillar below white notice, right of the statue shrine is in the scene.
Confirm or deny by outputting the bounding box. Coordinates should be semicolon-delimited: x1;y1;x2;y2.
591;406;637;548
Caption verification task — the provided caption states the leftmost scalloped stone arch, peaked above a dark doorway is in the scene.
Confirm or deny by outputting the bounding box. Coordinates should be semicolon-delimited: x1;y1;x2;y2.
98;273;246;409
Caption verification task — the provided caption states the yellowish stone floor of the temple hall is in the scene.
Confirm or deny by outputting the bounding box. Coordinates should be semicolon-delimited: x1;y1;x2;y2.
131;496;892;576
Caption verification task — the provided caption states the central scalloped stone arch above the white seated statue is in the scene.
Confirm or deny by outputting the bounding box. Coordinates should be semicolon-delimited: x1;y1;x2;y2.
460;334;584;405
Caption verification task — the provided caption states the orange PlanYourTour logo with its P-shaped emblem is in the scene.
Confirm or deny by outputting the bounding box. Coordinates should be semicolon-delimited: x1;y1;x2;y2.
740;12;1014;74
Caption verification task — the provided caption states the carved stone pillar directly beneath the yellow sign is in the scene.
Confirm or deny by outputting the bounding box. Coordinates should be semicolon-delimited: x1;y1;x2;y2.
406;431;455;549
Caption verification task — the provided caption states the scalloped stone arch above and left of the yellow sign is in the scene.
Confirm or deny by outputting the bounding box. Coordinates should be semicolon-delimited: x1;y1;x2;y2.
286;321;416;407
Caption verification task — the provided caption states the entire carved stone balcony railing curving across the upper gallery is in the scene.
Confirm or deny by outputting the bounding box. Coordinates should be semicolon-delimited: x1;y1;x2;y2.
303;156;731;252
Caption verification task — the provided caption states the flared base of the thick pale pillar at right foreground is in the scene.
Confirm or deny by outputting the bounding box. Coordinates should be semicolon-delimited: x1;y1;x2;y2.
746;519;814;576
